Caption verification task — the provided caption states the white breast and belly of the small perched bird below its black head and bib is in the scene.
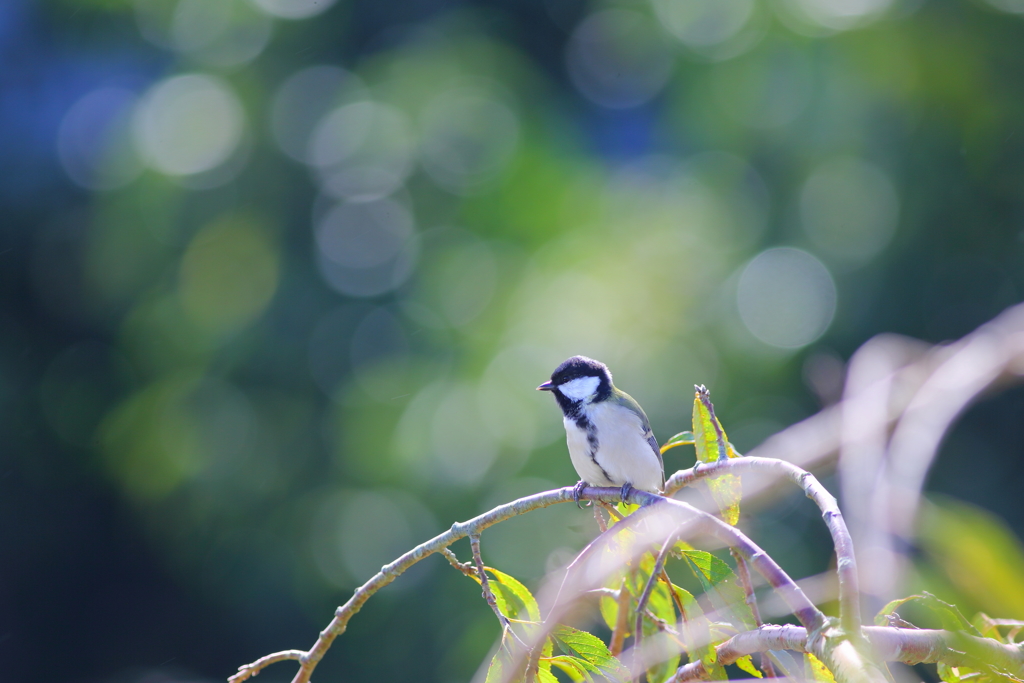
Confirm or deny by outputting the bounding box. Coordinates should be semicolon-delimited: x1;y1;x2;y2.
564;401;664;493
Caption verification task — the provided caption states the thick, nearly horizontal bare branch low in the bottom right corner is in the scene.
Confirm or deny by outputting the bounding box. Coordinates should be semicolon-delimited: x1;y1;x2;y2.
667;625;1024;683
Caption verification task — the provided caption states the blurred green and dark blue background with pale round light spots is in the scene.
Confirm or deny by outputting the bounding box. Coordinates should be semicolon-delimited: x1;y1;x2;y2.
6;0;1024;683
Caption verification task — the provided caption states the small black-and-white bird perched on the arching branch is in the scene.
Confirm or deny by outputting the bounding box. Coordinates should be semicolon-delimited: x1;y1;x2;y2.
537;355;665;505
